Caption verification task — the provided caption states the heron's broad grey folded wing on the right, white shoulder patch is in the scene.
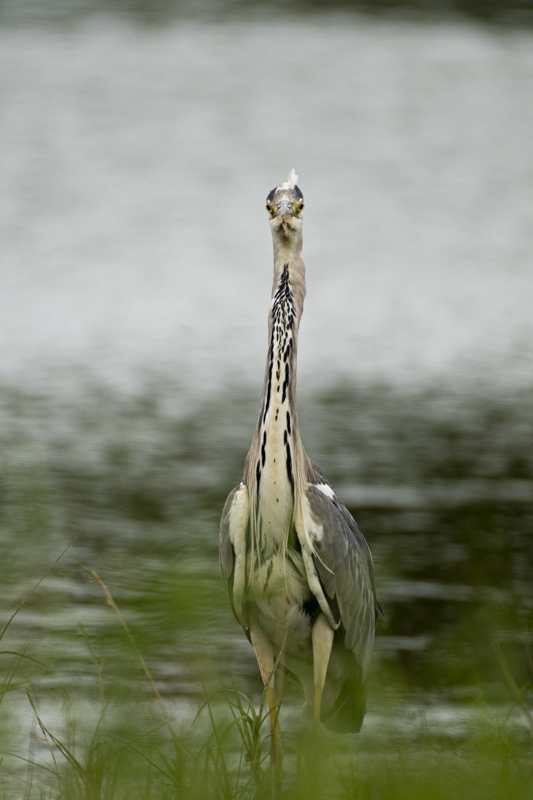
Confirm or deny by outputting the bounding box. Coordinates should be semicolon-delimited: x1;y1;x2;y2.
306;483;381;680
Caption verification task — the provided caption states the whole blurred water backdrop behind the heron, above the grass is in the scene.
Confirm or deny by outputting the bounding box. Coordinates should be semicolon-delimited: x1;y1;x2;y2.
0;0;533;797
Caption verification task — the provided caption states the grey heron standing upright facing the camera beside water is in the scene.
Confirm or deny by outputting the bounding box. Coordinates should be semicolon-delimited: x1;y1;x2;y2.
220;170;381;750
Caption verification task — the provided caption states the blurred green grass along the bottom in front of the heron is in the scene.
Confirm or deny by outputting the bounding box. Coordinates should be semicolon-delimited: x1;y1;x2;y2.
0;562;533;800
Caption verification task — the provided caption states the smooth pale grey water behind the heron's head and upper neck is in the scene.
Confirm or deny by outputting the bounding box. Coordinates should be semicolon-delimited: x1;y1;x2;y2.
0;16;533;394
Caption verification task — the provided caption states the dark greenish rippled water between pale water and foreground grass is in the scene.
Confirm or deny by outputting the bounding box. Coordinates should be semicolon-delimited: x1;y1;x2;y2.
0;384;533;716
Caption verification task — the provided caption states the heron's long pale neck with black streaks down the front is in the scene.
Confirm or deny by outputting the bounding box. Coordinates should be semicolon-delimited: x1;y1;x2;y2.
244;225;307;524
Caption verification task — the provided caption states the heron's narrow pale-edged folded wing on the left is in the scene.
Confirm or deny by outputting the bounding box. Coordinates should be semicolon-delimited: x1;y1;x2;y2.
219;483;250;628
